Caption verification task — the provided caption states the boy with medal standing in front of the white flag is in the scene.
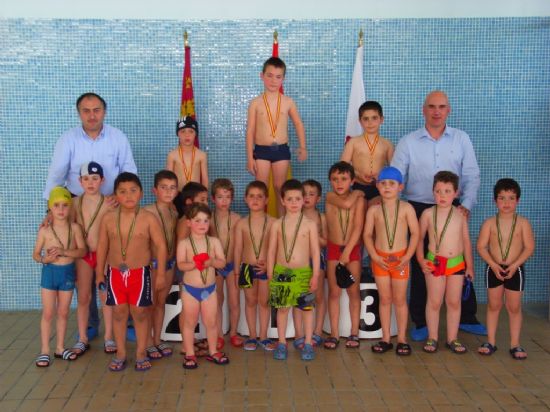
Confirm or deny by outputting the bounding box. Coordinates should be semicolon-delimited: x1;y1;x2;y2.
339;101;394;207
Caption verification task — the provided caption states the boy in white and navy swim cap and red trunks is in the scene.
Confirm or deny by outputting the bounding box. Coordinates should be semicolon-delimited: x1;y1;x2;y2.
72;162;116;356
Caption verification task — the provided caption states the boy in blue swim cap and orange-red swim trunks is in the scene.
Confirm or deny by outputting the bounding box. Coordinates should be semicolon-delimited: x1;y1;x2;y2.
363;167;418;356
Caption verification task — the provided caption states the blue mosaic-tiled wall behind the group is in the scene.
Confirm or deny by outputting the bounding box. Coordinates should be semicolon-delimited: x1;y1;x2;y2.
0;18;550;310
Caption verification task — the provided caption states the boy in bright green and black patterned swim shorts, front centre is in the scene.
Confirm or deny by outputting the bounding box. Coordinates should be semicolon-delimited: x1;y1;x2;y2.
267;179;320;360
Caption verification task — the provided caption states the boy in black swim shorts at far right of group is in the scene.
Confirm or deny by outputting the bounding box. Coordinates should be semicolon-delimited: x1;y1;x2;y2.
477;179;535;360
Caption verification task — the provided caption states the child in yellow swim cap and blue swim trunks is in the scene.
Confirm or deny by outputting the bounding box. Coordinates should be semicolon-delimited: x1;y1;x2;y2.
32;186;87;367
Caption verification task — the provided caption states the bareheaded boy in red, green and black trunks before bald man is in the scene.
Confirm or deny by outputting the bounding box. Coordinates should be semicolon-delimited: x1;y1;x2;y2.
416;171;474;354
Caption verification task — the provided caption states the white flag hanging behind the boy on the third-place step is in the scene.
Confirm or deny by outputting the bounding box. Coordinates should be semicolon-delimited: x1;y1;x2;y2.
345;35;365;142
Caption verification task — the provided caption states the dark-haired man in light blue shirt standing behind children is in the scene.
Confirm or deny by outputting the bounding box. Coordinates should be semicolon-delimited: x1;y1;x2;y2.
43;93;137;339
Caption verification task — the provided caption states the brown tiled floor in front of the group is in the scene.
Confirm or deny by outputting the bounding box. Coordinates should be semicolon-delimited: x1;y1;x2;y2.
0;307;550;412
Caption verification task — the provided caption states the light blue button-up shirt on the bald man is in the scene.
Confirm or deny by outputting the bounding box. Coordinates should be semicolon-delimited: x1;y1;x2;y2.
391;126;480;210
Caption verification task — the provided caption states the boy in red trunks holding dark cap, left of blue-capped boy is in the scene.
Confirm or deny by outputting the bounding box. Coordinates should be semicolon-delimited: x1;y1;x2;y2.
324;161;365;349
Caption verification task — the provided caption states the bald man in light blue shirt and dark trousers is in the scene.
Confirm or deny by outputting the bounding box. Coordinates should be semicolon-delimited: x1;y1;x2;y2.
391;90;487;341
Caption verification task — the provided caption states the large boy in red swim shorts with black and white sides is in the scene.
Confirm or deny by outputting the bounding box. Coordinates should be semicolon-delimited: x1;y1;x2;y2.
96;172;167;372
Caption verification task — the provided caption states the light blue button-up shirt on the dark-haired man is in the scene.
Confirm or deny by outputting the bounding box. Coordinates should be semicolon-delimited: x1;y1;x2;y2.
43;124;137;200
